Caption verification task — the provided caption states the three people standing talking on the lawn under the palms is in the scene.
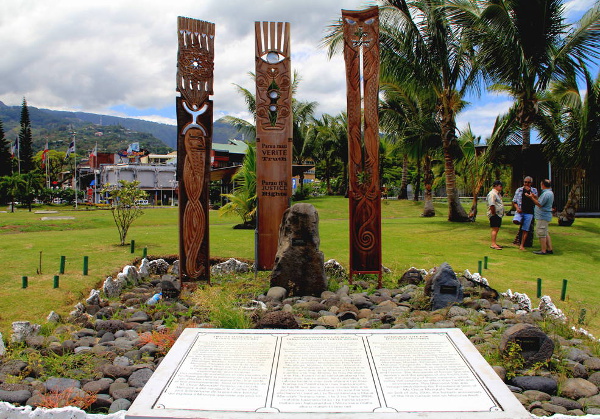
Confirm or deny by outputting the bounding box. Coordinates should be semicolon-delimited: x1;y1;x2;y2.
487;176;554;255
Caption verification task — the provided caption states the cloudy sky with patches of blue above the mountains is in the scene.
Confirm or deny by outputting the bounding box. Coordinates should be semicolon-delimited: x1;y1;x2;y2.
0;0;593;141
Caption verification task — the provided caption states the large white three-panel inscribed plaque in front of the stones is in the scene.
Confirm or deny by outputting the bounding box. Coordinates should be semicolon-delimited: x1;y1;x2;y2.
126;329;529;419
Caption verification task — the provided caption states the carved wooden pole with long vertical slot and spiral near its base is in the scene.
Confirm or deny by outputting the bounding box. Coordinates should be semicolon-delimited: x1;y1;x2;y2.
342;7;381;286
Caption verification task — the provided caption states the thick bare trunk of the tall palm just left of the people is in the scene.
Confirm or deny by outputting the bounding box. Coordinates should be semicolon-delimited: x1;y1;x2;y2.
441;107;469;222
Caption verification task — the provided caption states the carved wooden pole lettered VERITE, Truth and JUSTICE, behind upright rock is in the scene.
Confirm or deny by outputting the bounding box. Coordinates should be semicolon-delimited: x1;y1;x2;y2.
255;22;292;270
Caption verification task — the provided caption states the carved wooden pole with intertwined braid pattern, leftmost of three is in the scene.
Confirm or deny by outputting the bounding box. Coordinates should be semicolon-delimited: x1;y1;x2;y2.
176;17;215;282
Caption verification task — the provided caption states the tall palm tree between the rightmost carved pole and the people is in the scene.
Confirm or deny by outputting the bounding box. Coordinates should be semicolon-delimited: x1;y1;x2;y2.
324;0;477;221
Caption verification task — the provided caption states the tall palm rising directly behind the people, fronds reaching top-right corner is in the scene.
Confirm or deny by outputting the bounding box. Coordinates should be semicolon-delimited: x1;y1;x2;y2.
450;0;600;170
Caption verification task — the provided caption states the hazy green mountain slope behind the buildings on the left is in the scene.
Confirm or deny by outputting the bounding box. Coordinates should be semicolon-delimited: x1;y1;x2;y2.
0;101;242;153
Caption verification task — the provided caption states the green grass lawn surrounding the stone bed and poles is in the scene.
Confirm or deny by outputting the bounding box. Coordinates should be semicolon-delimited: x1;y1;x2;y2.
0;197;600;337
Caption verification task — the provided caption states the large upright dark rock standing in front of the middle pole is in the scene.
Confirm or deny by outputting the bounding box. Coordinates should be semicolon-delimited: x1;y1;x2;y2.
271;203;327;296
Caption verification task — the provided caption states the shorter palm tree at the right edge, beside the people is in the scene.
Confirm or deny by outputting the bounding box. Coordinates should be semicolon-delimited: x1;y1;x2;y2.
540;63;600;226
